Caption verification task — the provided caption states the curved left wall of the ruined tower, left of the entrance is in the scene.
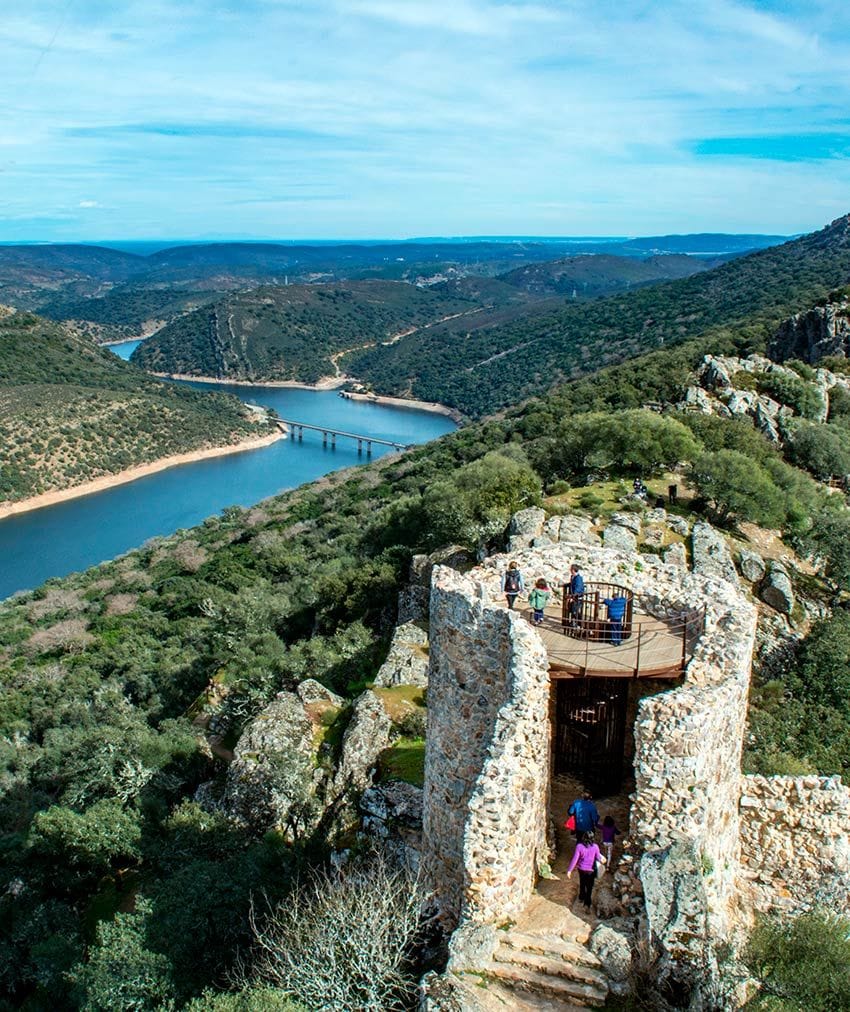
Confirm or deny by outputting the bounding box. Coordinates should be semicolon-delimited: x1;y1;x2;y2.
423;567;549;926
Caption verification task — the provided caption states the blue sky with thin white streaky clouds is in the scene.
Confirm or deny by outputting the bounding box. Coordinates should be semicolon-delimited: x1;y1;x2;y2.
0;0;850;241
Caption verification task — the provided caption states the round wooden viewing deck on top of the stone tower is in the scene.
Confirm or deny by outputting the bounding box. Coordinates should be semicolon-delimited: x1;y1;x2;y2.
521;605;690;678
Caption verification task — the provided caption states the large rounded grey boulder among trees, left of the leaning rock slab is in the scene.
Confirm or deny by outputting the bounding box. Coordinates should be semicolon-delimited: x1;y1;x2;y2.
222;692;313;829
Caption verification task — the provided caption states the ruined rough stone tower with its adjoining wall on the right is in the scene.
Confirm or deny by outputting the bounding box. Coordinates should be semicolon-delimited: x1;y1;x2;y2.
422;534;850;1008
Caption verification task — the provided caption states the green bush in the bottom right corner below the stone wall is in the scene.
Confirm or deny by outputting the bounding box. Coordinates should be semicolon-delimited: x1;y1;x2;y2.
744;912;850;1012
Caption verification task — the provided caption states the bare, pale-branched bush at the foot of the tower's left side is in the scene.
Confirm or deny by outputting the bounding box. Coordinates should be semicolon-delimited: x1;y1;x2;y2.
245;855;421;1012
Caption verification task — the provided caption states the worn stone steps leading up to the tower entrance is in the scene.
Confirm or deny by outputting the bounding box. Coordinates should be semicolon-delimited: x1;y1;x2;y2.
481;929;608;1010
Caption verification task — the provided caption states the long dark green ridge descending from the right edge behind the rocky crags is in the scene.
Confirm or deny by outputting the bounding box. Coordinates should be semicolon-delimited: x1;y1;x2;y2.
347;217;850;415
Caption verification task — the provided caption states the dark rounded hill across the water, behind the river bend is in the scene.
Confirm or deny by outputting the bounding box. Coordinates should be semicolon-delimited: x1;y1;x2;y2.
133;281;479;383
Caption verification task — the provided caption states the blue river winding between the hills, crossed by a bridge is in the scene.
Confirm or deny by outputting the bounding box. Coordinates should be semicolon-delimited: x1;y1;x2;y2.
0;342;455;598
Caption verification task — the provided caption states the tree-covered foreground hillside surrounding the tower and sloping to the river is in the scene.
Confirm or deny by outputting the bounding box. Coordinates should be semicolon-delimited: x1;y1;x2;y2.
0;271;850;1012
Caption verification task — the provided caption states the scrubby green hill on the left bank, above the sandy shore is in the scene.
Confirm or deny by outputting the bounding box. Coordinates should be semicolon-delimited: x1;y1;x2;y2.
0;311;263;501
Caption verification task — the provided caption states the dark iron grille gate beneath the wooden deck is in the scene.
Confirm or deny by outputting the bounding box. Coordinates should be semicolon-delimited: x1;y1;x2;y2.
555;678;628;794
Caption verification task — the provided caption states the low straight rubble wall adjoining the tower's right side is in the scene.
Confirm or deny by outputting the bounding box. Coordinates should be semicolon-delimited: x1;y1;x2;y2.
741;776;850;913
